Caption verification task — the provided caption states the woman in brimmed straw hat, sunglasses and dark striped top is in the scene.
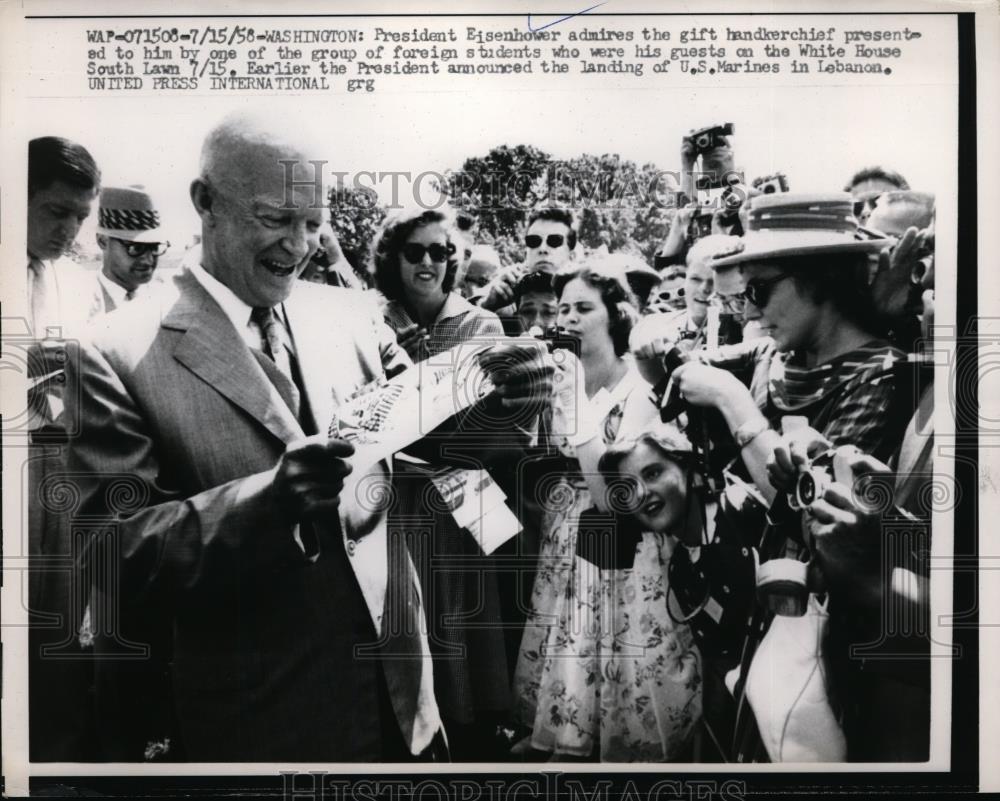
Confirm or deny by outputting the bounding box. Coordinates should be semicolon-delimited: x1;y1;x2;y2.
674;194;906;501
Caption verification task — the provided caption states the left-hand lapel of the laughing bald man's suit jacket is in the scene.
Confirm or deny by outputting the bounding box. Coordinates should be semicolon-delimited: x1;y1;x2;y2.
168;273;304;443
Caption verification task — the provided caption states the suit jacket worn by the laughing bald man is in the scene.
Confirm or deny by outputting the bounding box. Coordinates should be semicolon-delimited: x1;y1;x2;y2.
67;272;409;761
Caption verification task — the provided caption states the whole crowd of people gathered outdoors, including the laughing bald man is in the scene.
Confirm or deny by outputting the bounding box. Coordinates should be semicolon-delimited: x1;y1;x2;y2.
26;114;934;762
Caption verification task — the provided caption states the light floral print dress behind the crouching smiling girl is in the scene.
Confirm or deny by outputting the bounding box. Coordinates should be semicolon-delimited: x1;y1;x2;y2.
514;368;701;762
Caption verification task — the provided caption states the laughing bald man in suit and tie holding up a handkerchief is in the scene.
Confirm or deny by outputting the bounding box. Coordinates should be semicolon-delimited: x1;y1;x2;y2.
69;112;551;762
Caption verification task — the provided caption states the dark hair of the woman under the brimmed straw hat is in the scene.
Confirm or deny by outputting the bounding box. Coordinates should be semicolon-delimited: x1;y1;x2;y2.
768;253;885;336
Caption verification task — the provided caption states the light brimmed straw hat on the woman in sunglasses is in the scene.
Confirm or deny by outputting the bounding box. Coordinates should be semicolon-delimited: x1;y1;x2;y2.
711;192;894;267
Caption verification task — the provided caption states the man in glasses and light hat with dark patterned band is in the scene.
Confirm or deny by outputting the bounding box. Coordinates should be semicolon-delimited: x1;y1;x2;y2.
90;186;170;317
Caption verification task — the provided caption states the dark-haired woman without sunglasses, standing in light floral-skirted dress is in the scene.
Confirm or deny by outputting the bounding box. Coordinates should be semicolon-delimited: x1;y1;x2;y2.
514;261;700;761
